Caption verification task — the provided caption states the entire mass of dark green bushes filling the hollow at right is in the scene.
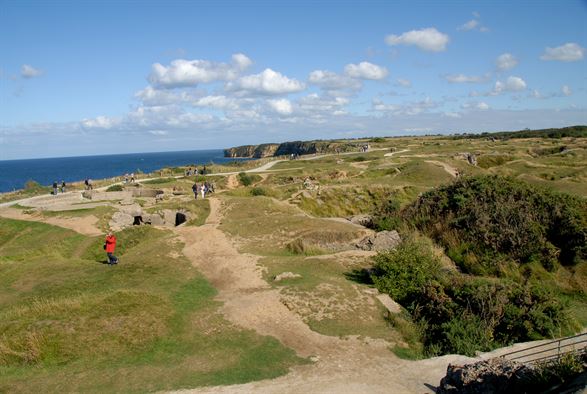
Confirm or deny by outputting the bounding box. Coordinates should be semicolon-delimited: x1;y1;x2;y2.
373;176;587;355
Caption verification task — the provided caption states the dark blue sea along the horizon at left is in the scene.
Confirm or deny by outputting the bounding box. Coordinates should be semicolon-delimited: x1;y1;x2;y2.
0;149;247;192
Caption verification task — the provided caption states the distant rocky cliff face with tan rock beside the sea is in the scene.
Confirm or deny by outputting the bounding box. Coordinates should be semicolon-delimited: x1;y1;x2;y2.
224;141;357;158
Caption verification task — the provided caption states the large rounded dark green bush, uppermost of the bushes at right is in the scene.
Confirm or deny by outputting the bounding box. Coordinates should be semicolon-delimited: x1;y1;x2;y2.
403;176;587;274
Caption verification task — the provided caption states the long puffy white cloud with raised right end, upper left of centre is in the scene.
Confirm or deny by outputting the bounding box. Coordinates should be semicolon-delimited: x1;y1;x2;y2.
148;53;252;88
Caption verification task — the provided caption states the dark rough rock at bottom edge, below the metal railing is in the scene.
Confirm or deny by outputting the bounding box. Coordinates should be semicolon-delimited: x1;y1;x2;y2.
436;358;532;394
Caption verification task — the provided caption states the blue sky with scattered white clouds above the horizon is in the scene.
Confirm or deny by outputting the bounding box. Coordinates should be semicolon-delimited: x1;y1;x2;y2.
0;0;587;160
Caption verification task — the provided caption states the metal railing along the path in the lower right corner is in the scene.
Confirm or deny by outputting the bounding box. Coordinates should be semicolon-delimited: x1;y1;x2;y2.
499;332;587;364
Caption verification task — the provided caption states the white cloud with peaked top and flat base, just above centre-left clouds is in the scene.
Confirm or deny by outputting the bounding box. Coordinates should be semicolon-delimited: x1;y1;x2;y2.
226;68;305;94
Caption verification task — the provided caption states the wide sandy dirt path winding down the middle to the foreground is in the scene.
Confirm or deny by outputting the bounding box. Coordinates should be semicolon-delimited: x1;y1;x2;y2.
175;198;467;393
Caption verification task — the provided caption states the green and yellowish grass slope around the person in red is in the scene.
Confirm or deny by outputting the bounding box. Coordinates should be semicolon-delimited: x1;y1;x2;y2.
0;219;302;392
